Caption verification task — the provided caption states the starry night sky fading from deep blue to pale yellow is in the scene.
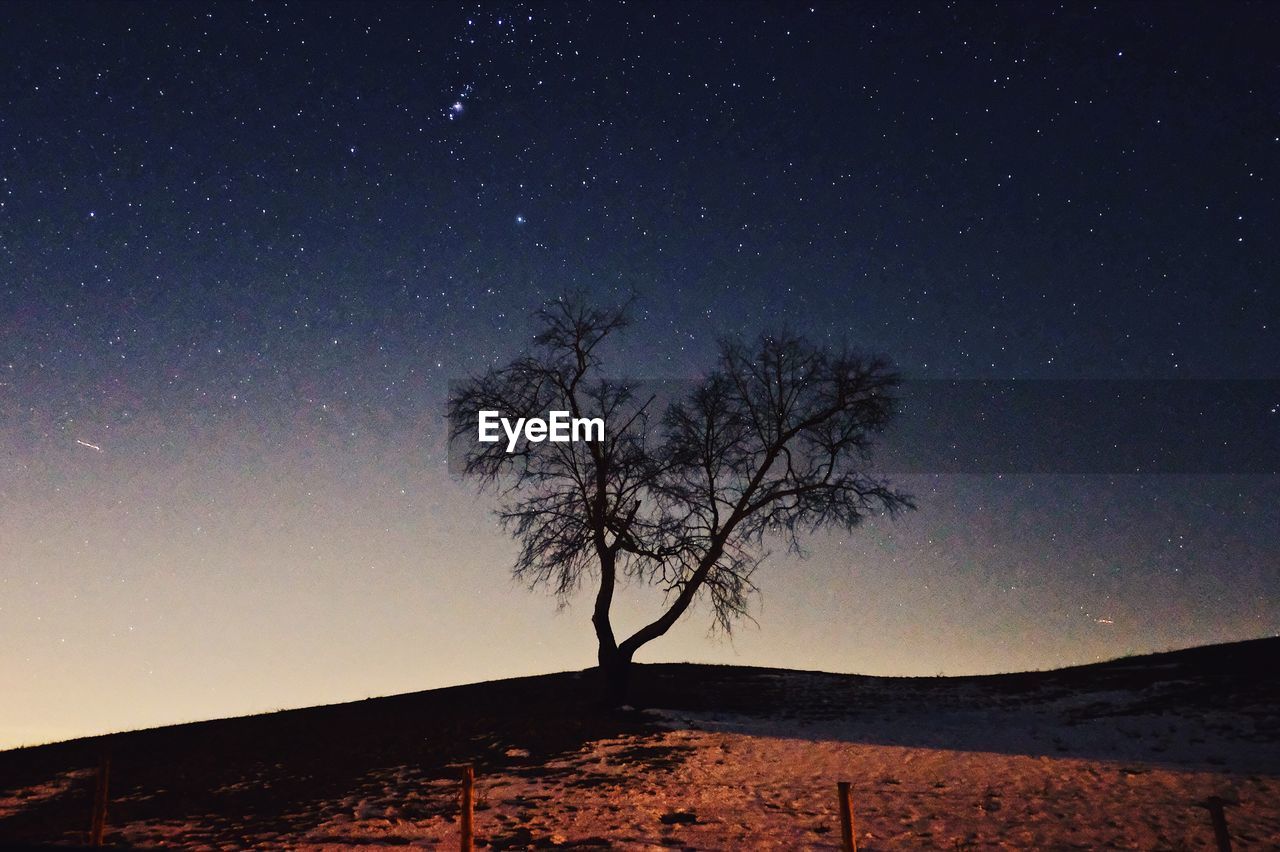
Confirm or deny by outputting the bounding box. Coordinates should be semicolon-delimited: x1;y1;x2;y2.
0;3;1280;745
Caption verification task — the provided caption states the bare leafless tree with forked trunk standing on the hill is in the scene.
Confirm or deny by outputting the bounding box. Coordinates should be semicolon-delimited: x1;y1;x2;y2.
449;298;914;704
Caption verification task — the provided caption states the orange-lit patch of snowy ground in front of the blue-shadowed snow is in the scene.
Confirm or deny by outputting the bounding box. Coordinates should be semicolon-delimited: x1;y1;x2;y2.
270;729;1280;849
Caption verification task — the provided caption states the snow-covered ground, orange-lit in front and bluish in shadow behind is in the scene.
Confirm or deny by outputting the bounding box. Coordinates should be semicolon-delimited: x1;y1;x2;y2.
112;673;1280;849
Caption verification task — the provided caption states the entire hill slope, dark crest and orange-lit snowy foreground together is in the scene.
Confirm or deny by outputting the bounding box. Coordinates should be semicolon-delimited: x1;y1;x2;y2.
0;638;1280;849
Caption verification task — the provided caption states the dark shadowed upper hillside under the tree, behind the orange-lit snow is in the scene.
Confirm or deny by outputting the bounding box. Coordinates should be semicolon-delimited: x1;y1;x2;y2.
0;638;1280;846
